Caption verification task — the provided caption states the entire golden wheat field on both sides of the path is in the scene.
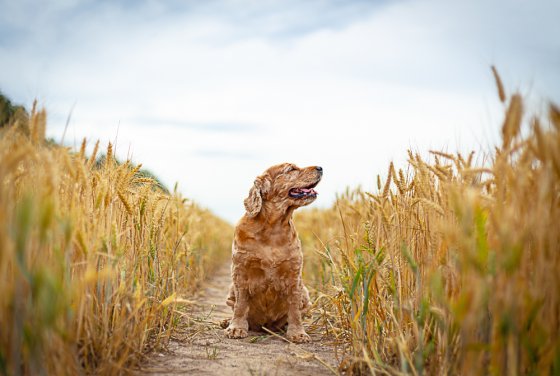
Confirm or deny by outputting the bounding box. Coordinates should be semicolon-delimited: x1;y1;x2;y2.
0;73;560;375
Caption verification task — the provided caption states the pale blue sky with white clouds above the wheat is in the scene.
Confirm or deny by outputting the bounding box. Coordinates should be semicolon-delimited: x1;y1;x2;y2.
0;0;560;223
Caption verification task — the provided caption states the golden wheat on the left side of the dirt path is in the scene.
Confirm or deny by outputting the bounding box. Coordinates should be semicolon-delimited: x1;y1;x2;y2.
0;102;232;375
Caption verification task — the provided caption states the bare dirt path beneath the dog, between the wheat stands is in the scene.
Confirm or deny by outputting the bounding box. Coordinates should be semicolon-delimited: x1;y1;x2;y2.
138;265;337;376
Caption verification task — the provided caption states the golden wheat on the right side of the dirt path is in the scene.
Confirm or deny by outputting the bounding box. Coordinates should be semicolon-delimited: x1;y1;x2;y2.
296;80;560;375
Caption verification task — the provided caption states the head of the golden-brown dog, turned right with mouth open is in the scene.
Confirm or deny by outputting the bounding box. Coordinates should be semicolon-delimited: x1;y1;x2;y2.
244;163;323;217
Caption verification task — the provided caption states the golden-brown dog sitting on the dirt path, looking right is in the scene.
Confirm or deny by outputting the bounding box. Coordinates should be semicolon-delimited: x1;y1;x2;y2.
223;163;323;343
